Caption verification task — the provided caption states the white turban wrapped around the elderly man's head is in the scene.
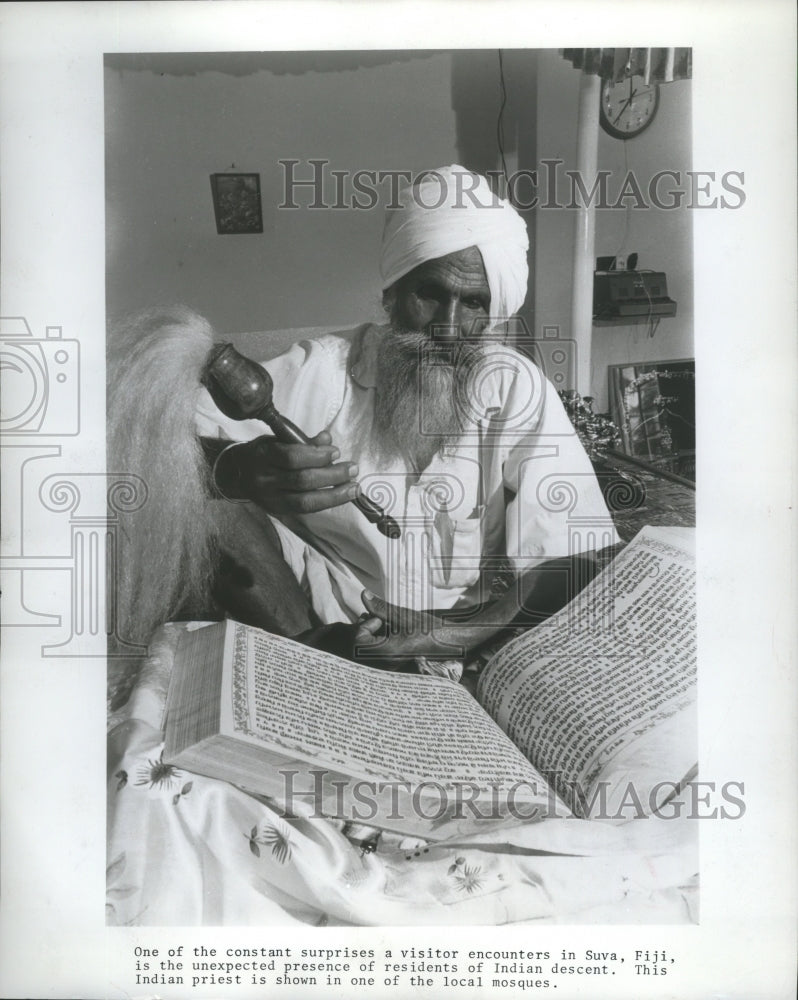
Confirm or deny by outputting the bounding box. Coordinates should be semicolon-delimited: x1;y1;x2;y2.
380;164;529;326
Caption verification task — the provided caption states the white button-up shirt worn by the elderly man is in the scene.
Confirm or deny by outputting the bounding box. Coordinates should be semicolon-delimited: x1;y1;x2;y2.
197;325;618;610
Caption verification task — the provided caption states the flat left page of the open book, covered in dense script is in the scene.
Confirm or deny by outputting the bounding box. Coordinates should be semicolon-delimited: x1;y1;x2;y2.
224;623;546;795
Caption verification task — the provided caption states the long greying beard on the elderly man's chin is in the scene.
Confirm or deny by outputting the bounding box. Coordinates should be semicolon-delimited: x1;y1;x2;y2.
372;324;481;472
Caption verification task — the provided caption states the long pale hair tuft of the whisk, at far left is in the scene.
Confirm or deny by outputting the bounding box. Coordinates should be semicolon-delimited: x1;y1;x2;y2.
107;306;217;642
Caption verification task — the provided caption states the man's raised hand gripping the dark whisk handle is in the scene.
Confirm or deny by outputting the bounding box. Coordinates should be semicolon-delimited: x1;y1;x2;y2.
216;431;359;514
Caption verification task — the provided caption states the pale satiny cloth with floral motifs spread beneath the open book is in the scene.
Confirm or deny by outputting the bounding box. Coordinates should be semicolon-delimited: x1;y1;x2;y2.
106;624;698;926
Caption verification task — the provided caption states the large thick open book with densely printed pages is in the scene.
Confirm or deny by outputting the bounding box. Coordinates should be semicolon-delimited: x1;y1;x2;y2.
164;528;696;839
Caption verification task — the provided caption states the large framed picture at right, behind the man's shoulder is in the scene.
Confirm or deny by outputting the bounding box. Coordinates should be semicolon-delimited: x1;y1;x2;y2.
609;358;695;480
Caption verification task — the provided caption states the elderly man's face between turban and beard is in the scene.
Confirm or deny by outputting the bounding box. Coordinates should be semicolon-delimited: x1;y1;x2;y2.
391;247;490;343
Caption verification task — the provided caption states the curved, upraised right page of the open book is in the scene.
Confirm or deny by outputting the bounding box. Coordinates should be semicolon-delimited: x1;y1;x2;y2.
479;528;696;807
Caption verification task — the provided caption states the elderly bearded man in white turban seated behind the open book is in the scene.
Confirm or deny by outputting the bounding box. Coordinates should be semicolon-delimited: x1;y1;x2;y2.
189;166;616;672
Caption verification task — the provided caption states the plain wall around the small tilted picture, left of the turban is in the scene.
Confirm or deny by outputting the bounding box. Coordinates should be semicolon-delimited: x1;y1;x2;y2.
106;54;466;332
